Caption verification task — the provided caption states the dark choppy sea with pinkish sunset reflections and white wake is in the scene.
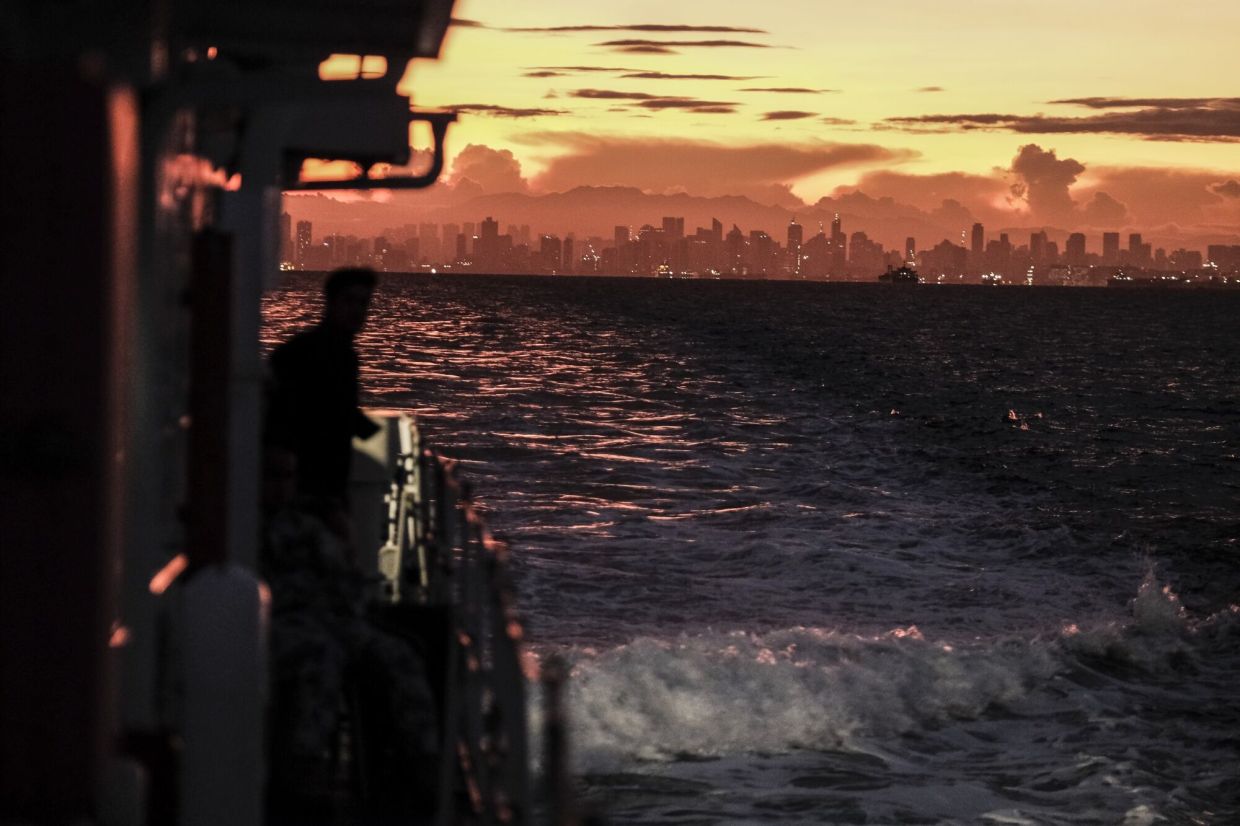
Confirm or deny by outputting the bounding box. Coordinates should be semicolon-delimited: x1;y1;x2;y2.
264;275;1240;826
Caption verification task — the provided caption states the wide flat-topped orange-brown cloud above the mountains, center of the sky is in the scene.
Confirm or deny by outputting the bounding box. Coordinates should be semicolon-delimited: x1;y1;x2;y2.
523;133;915;207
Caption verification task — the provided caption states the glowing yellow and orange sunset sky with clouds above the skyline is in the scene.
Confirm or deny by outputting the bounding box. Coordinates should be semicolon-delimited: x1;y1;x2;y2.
287;0;1240;244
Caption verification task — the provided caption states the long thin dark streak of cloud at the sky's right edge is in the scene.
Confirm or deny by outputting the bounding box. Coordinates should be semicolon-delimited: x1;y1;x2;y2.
883;98;1240;141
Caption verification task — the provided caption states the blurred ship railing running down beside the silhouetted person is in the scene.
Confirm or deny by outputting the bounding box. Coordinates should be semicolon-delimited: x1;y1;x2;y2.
362;414;534;826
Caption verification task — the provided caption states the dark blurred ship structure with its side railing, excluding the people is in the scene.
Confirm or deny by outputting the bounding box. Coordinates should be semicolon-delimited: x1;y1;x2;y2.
0;0;567;826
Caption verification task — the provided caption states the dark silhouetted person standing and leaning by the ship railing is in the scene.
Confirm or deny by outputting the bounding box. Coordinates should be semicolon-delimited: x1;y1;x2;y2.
267;269;378;508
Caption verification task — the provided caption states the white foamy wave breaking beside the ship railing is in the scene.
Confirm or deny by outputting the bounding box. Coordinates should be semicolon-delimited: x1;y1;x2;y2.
545;577;1240;773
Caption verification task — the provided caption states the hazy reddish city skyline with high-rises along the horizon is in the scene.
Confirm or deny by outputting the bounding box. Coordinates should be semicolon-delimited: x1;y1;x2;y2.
280;212;1240;286
